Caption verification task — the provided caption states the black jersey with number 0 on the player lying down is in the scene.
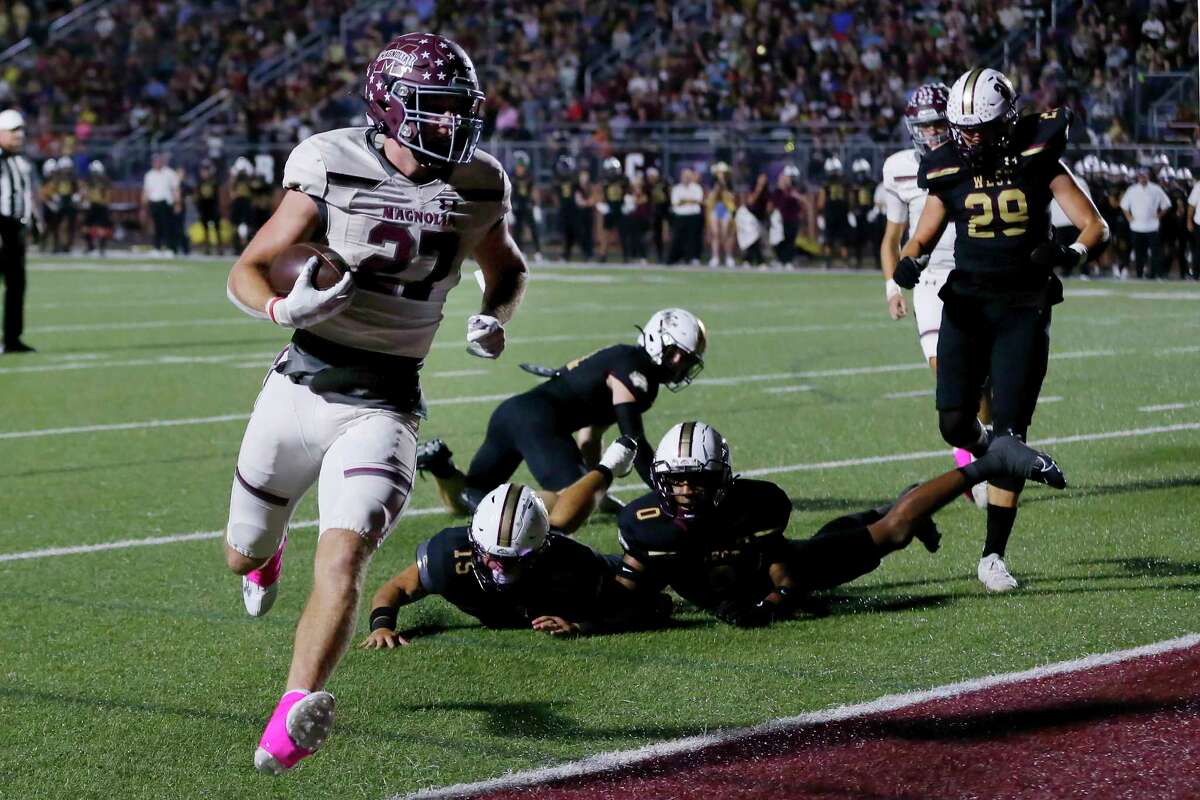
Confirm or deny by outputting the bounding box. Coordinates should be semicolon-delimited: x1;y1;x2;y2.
618;480;792;609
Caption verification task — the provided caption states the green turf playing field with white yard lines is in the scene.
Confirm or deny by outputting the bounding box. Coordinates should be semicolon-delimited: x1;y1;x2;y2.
0;259;1200;800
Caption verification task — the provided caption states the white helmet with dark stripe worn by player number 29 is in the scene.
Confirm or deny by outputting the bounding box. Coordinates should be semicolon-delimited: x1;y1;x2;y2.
946;67;1018;164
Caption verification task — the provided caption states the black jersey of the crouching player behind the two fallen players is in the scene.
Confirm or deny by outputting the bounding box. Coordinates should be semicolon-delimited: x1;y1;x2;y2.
532;344;660;431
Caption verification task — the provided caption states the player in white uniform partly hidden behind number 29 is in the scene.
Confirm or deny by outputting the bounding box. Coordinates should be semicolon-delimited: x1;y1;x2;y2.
880;83;991;509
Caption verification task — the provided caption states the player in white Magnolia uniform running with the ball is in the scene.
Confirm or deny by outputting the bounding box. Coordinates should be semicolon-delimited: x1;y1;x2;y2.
226;34;526;774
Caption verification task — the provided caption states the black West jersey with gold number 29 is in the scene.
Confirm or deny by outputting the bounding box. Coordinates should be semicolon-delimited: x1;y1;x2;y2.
917;108;1072;294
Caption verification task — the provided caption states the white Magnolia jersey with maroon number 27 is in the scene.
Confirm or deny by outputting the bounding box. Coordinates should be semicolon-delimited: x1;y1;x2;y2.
283;127;510;359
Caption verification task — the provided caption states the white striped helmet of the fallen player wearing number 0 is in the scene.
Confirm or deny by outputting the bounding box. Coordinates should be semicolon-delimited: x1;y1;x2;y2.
650;421;733;519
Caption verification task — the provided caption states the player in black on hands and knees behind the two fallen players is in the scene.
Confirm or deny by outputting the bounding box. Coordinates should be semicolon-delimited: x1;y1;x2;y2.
416;308;708;513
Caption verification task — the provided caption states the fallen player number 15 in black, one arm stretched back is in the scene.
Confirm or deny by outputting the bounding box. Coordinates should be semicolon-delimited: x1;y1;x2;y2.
360;437;671;650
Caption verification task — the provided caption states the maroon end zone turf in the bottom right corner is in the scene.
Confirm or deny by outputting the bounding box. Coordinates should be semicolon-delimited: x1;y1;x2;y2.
470;646;1200;800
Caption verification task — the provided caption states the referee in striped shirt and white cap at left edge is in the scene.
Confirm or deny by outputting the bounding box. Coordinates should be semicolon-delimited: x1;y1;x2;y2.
0;108;37;353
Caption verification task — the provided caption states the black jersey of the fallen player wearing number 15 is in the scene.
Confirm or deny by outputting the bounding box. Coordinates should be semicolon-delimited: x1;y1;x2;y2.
416;527;634;627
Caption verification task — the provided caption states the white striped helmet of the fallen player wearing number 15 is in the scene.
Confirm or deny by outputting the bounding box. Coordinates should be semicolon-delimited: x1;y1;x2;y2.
469;483;550;590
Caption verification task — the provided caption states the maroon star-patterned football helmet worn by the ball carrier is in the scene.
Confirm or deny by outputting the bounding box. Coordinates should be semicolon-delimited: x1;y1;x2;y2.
362;34;484;166
